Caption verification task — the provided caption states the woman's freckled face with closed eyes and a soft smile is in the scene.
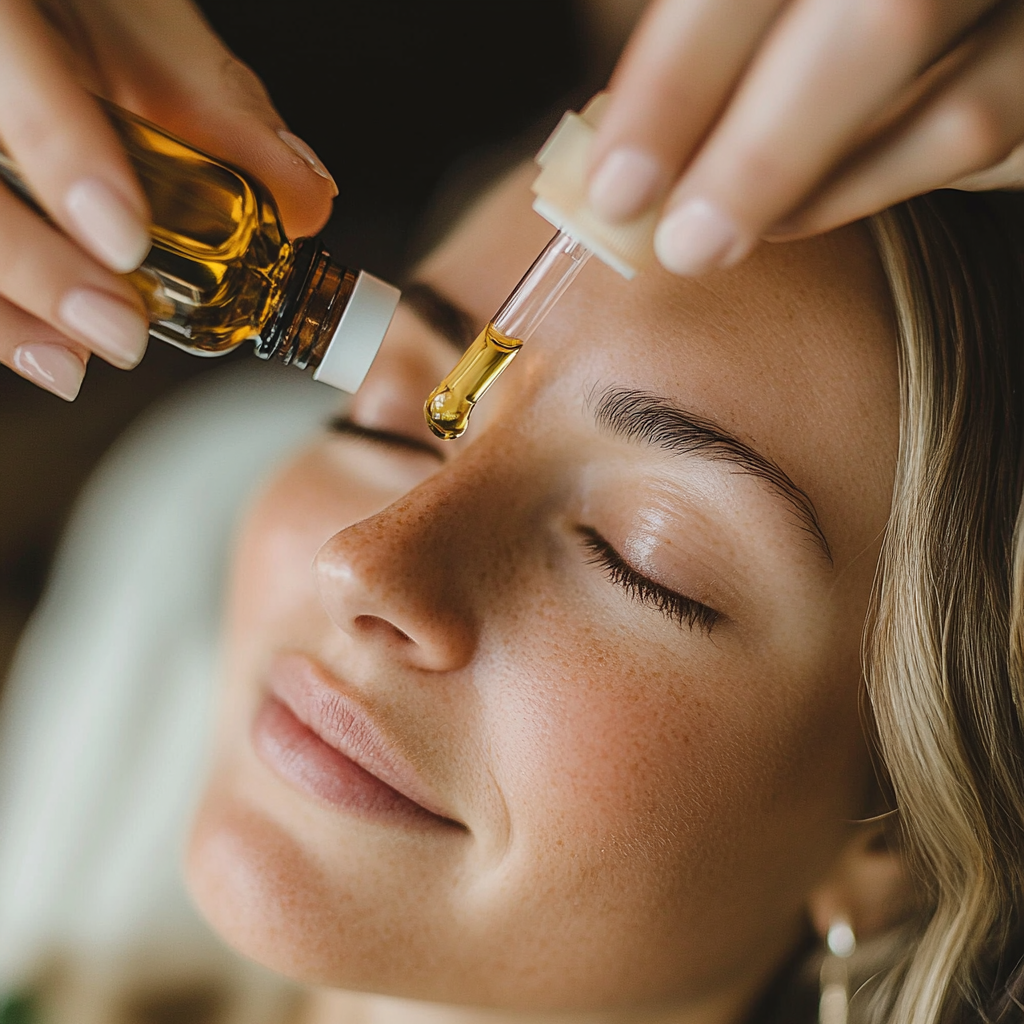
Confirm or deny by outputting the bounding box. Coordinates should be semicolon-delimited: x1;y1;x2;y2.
188;165;897;1016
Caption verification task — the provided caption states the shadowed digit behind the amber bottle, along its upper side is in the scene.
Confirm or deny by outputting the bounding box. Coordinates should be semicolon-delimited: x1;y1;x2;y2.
94;0;338;238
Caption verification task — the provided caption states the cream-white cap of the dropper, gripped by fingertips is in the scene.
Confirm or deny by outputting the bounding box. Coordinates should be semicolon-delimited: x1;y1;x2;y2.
534;93;657;280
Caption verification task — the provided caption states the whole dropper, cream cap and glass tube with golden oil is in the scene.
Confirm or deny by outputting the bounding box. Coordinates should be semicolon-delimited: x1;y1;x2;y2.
423;96;655;440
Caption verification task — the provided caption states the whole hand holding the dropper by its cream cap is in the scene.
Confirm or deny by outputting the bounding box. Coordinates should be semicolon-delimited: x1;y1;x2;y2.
589;0;1024;274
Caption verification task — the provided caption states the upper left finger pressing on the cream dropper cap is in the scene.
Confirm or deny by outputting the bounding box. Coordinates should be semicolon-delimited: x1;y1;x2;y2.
589;0;785;221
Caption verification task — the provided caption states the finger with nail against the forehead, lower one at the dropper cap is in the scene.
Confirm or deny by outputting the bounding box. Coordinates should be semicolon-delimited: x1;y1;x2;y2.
655;0;986;274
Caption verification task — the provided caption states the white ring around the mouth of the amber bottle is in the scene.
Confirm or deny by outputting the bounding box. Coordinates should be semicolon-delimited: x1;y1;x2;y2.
313;270;401;394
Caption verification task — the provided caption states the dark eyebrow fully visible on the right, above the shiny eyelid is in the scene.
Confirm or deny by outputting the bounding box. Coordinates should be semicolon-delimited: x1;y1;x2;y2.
588;388;833;565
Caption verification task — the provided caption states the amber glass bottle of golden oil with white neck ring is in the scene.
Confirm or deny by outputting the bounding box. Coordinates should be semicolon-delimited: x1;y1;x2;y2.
0;103;400;391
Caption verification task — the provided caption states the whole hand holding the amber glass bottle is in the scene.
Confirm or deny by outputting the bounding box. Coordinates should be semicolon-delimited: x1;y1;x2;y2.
0;0;337;400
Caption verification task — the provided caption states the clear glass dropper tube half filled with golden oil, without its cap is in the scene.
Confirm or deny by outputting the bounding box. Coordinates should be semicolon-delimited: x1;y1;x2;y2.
423;231;591;440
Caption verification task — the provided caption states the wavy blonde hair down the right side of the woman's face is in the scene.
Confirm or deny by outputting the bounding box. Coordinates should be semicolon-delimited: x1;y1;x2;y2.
864;191;1024;1024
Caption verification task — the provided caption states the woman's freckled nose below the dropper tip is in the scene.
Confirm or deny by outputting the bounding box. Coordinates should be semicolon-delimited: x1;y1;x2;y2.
313;474;477;672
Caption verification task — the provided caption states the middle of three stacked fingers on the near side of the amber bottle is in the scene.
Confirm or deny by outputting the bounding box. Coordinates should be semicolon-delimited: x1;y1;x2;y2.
0;182;148;370
